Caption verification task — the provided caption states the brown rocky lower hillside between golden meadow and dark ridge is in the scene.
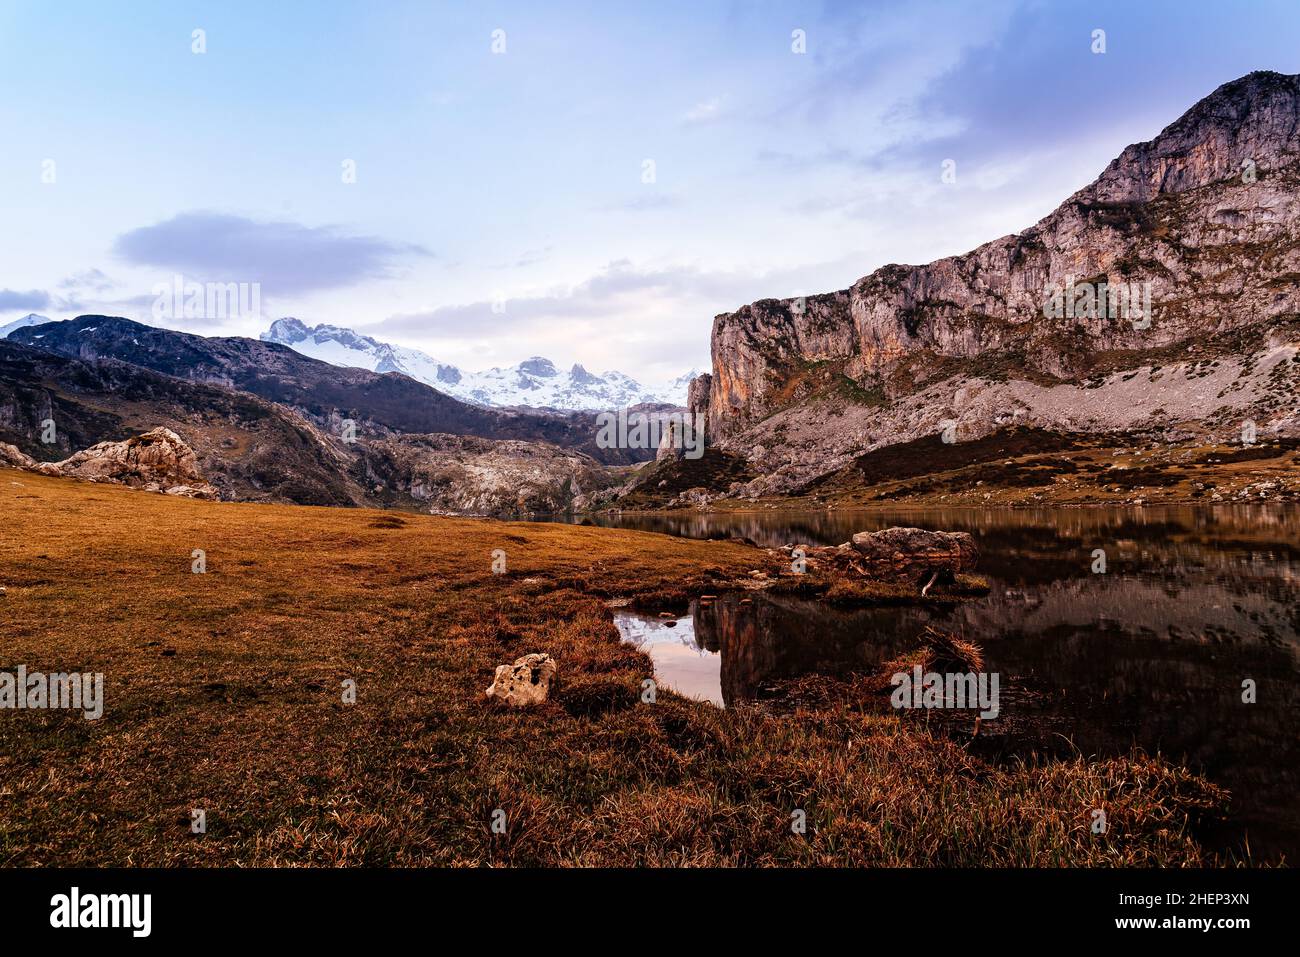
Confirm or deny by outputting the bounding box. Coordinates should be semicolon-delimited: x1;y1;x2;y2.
0;341;611;516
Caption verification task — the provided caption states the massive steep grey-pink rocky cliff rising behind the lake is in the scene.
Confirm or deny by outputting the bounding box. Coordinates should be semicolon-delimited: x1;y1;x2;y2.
689;73;1300;495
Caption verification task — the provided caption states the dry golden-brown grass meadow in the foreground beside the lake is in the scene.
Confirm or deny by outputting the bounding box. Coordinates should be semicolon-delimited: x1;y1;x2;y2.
0;471;1225;866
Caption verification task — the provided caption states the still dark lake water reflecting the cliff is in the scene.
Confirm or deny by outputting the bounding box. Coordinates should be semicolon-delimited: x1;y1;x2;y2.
585;505;1300;863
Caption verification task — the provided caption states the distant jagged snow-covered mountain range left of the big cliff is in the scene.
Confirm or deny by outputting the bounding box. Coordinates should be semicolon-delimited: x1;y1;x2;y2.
261;319;699;410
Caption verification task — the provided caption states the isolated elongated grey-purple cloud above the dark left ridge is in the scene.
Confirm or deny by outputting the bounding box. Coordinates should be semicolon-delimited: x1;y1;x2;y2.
113;211;430;295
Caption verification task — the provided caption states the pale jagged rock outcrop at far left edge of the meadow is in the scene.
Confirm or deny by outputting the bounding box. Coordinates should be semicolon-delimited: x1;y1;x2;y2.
35;429;218;498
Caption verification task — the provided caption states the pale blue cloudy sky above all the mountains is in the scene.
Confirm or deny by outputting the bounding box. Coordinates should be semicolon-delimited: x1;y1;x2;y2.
0;0;1300;382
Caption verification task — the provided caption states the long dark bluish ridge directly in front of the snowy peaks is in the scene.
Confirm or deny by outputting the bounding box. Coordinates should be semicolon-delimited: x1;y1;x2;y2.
9;316;654;464
